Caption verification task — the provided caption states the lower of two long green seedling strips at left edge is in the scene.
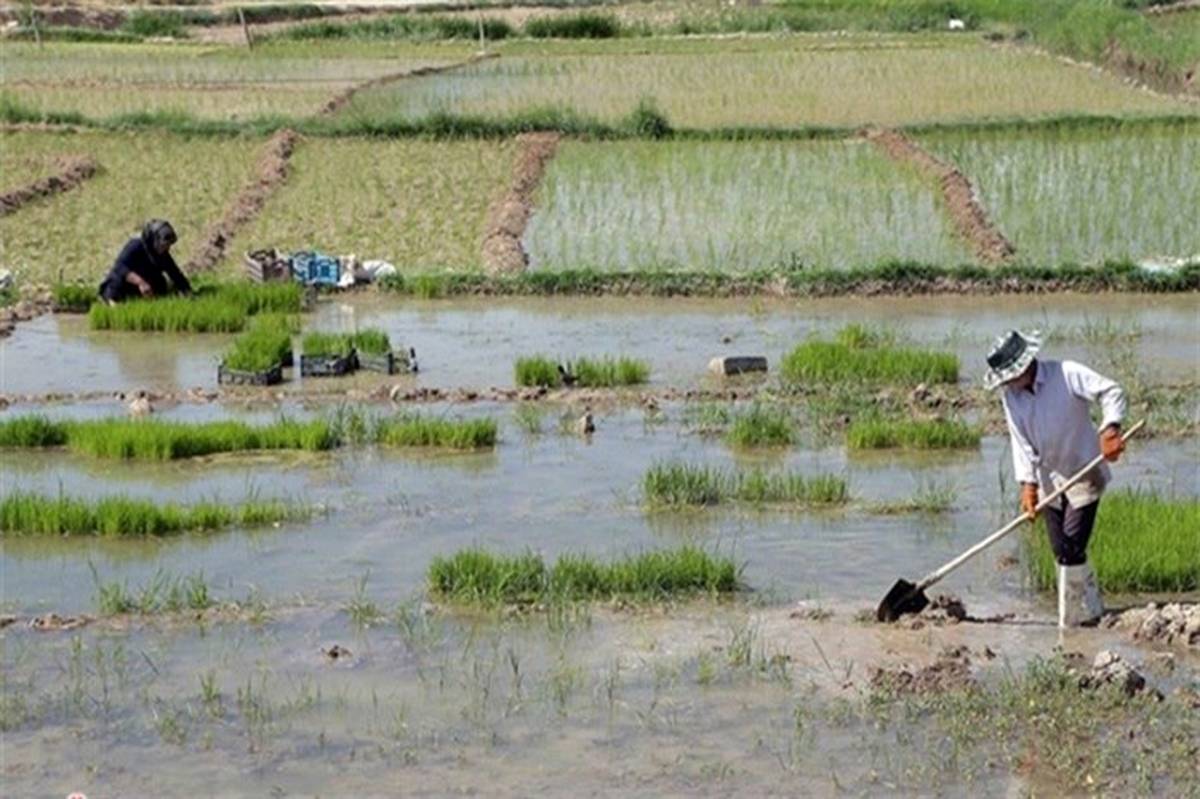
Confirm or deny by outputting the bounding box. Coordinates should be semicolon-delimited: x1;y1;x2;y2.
0;491;302;537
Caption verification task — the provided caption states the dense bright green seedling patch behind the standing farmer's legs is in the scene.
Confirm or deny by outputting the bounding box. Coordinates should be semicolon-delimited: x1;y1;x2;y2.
1024;491;1200;591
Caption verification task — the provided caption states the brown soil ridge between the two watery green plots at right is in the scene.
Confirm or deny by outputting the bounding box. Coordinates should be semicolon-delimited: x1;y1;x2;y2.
863;127;1016;264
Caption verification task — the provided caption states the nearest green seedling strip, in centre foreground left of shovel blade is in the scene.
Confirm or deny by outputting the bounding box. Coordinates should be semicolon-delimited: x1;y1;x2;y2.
428;547;740;606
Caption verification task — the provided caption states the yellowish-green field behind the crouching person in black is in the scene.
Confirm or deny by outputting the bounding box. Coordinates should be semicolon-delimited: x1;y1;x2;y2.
0;131;262;284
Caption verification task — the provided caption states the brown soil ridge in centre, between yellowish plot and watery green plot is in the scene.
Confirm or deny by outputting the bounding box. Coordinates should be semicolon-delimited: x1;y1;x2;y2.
482;133;562;274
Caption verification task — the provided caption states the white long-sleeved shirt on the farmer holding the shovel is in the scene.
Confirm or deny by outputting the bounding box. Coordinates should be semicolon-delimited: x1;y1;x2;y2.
1003;359;1126;507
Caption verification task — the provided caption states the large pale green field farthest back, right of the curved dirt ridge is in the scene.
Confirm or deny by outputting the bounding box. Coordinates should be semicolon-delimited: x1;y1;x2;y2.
346;36;1190;130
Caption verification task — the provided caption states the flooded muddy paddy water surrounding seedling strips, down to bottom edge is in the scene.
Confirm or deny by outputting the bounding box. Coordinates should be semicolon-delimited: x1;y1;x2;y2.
0;296;1200;797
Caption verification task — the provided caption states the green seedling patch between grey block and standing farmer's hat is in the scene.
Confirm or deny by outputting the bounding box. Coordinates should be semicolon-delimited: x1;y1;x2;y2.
780;326;959;388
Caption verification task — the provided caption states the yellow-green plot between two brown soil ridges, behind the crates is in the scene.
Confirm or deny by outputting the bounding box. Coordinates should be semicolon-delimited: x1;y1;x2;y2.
228;139;512;269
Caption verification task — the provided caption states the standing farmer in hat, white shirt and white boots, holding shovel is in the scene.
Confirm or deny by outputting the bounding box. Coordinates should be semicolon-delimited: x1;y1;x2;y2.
984;330;1126;627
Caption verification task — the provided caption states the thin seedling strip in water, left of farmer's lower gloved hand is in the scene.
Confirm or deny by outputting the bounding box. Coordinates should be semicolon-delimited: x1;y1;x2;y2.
642;461;850;507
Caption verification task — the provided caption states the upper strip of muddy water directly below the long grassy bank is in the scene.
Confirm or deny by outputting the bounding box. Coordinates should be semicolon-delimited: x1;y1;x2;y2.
0;295;1200;394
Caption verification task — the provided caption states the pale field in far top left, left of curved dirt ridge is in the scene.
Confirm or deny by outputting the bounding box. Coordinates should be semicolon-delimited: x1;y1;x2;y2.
0;43;456;119
